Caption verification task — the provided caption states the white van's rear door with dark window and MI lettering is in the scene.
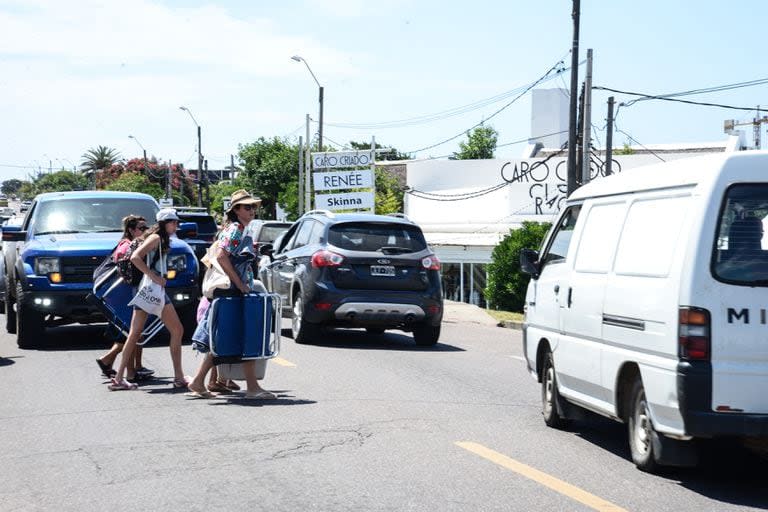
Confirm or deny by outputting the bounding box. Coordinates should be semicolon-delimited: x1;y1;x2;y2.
702;183;768;413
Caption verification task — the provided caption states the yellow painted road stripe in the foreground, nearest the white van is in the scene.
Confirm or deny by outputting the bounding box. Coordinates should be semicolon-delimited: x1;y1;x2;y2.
455;441;627;512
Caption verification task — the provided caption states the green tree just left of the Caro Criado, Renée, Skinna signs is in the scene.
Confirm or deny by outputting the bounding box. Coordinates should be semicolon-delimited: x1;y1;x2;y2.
238;137;299;219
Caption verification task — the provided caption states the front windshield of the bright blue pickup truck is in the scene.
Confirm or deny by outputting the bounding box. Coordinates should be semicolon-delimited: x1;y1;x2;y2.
31;198;157;235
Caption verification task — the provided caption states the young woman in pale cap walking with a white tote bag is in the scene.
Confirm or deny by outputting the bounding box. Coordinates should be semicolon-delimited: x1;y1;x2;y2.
109;208;191;391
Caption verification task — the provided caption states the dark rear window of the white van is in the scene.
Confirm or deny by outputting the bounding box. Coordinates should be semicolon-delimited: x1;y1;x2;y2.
712;184;768;286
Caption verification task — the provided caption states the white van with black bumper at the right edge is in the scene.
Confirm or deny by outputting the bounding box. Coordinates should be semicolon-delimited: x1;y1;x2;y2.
520;151;768;471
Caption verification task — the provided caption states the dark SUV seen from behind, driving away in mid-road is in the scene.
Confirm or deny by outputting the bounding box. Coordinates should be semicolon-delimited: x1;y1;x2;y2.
261;210;443;345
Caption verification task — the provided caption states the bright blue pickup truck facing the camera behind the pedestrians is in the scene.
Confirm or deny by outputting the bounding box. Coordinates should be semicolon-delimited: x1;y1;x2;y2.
0;191;199;348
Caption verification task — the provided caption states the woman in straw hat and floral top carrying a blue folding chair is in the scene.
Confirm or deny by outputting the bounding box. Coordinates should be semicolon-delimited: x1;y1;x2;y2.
189;189;277;399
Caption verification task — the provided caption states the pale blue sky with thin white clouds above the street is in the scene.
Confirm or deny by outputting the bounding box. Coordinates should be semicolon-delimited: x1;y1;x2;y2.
0;0;768;181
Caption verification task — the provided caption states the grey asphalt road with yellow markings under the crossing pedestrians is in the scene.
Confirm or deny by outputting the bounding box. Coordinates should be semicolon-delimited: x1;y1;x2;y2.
0;302;768;512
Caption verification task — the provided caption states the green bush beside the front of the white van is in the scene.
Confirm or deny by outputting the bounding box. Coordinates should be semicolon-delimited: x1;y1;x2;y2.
485;222;551;312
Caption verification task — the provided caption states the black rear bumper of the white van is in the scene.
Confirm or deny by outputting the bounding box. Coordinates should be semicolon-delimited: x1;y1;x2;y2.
677;362;768;437
